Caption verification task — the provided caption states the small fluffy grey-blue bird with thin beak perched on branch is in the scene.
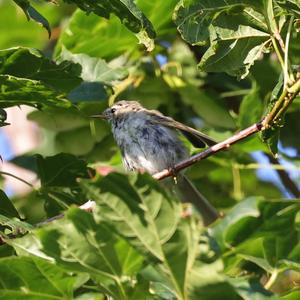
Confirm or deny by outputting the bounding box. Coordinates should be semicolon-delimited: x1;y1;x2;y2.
92;100;218;225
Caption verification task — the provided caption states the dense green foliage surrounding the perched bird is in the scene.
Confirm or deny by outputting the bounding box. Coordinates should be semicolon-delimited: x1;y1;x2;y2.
0;0;300;300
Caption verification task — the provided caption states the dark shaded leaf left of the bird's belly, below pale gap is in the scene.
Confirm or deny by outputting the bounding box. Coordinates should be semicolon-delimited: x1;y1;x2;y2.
36;153;90;187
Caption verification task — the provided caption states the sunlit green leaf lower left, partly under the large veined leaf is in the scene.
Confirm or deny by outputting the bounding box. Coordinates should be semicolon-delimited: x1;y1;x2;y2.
18;208;143;299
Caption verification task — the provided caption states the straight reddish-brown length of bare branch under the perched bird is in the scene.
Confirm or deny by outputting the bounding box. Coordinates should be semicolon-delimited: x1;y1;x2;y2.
153;122;262;180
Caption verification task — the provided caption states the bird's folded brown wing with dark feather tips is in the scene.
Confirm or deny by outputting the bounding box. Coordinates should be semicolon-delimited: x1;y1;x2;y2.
147;110;217;148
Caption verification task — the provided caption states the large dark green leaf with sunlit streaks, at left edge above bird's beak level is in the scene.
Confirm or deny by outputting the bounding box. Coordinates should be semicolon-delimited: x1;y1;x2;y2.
0;48;82;107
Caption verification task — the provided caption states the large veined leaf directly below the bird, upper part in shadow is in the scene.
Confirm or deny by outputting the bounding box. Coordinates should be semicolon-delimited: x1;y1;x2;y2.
82;174;179;260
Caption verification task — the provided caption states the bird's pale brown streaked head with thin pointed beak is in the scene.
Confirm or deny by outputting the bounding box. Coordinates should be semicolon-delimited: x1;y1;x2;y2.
91;100;143;121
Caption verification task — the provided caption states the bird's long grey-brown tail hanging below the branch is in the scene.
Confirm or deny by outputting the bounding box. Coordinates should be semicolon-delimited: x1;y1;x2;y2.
177;175;219;226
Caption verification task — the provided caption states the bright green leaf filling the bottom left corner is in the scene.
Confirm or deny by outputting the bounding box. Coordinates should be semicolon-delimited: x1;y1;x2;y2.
0;257;77;300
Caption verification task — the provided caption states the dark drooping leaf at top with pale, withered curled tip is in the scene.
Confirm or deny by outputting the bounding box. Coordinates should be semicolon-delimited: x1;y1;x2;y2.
64;0;155;51
